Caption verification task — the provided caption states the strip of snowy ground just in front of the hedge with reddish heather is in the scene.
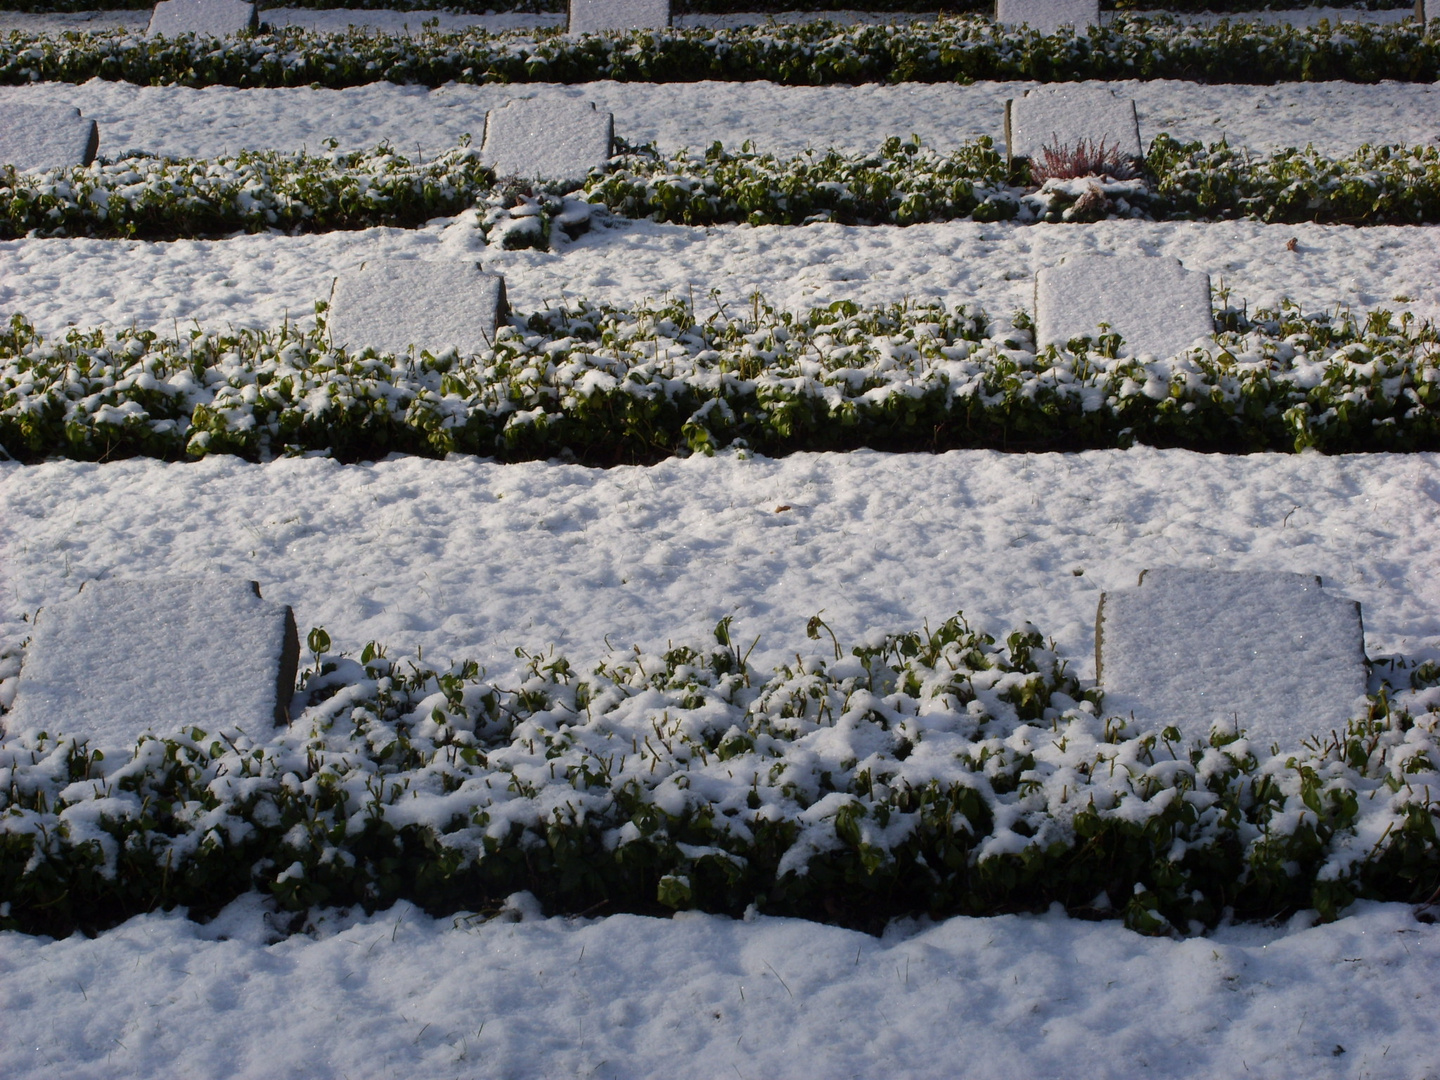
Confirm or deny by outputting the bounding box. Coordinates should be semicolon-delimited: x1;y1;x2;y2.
0;216;1440;333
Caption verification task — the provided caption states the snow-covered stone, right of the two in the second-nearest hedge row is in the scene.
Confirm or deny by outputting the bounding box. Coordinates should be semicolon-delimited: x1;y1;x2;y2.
1035;255;1215;359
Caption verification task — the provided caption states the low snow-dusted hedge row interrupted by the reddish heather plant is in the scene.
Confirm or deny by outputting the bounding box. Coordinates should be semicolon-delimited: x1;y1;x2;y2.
16;134;1440;248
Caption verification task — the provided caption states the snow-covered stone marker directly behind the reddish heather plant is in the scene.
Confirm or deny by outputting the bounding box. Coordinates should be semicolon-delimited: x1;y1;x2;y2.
1005;82;1145;166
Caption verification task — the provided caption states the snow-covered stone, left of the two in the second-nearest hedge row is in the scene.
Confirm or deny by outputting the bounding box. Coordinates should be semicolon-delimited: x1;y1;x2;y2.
330;261;507;356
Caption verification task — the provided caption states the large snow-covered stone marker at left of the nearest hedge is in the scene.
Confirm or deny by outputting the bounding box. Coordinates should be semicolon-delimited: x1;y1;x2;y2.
4;577;300;750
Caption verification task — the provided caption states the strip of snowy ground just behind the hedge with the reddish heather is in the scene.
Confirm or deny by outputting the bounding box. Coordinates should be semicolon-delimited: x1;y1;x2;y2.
0;79;1440;158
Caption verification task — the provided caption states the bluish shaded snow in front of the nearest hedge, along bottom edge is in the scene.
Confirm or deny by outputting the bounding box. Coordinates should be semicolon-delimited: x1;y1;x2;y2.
0;901;1440;1080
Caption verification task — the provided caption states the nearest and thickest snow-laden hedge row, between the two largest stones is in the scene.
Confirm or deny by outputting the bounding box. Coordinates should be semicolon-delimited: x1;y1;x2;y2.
0;615;1440;933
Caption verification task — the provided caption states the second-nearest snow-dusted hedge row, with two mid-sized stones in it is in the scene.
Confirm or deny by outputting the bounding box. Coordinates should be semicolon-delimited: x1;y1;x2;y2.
0;297;1440;465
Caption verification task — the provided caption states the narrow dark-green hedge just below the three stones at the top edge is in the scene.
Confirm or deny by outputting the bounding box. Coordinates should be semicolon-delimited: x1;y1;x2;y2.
0;16;1440;88
